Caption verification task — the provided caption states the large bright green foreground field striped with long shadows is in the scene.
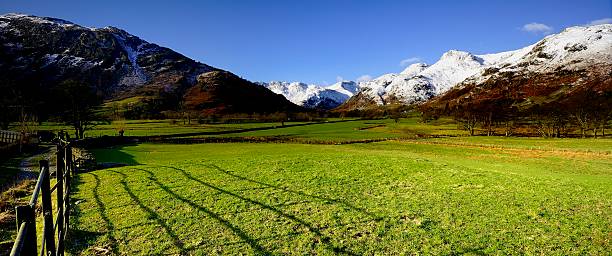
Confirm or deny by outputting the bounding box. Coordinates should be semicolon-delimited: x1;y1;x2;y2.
69;133;612;255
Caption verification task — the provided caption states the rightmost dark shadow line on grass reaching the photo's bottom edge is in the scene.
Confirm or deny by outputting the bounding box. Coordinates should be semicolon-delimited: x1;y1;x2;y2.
149;166;358;255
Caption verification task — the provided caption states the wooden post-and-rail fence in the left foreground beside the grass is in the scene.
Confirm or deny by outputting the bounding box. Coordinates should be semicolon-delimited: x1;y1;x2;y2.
11;140;75;256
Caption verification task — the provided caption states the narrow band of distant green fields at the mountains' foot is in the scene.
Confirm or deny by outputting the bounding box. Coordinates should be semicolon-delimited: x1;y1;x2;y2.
21;117;467;141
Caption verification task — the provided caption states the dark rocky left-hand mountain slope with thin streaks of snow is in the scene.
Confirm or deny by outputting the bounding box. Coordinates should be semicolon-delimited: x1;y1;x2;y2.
0;14;299;115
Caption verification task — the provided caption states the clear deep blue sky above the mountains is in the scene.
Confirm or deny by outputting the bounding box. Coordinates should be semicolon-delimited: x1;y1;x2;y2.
0;0;612;84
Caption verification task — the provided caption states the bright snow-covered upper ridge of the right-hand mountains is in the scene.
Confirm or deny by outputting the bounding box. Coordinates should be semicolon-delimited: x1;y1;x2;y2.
342;24;612;108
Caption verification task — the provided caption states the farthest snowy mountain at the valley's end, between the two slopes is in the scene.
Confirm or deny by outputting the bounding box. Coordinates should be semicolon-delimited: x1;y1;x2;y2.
258;81;359;109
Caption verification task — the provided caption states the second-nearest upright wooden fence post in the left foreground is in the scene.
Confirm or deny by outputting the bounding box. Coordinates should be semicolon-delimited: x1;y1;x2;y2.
40;160;55;255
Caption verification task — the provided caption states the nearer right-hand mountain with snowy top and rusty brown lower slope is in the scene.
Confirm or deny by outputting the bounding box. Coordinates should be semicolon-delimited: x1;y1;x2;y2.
422;24;612;116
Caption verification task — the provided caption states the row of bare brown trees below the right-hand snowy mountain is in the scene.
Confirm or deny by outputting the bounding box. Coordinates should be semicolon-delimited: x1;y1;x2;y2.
419;87;612;138
